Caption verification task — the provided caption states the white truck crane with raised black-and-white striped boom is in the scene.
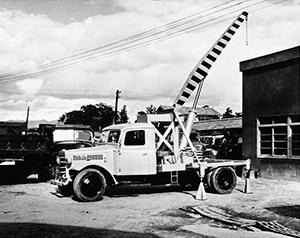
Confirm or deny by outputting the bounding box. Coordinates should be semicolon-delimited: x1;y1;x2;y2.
51;12;250;202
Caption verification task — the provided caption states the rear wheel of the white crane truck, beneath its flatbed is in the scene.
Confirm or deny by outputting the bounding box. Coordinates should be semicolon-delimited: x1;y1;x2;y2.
207;167;236;194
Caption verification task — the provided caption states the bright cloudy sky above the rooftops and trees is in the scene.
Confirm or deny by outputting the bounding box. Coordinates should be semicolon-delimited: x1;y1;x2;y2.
0;0;300;124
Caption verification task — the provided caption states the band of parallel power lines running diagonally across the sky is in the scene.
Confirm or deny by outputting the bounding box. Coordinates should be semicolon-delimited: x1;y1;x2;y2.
0;0;286;82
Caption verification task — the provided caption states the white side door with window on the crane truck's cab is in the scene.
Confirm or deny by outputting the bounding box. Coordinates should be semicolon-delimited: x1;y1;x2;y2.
116;130;155;175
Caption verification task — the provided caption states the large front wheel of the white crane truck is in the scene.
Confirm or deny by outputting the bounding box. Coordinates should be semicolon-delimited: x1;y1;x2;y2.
73;169;106;202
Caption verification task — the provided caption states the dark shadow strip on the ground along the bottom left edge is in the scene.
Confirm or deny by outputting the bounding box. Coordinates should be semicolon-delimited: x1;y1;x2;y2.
0;223;158;238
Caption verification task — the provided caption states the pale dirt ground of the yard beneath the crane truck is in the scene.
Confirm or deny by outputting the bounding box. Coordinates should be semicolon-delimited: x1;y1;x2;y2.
0;173;300;238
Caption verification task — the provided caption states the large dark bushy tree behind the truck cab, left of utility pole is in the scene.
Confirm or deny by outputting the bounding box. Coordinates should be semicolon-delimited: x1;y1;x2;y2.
59;103;114;131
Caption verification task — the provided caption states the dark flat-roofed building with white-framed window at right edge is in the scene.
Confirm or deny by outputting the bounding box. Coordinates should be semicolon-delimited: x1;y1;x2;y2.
240;46;300;181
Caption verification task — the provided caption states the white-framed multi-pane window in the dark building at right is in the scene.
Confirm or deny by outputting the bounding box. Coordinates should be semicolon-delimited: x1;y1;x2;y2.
258;115;300;158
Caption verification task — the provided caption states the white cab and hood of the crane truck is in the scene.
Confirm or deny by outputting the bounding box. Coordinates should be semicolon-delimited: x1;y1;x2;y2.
65;123;156;176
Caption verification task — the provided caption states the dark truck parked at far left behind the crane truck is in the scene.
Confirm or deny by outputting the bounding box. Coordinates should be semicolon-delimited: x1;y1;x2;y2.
0;122;94;181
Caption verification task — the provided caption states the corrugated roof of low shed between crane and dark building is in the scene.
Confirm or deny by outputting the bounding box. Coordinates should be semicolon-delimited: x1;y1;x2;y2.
193;117;243;131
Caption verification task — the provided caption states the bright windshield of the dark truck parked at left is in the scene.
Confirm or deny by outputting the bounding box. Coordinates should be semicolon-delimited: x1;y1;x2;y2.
53;129;93;142
